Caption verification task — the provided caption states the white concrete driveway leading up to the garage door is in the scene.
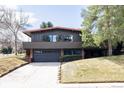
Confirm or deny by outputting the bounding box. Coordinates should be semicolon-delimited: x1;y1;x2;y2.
0;62;60;88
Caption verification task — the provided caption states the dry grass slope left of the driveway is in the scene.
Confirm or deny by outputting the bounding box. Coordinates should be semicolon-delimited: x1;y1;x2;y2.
0;55;27;77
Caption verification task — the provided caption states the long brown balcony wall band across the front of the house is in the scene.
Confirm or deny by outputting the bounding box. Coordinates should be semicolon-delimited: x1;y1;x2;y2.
23;42;82;49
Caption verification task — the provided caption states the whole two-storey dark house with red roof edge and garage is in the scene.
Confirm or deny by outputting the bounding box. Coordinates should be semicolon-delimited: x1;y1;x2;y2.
23;27;83;62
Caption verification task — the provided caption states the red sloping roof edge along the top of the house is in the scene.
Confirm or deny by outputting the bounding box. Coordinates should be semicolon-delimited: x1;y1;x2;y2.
23;26;81;36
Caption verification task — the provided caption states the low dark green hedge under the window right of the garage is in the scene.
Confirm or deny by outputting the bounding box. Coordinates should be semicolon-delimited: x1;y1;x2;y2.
60;55;82;62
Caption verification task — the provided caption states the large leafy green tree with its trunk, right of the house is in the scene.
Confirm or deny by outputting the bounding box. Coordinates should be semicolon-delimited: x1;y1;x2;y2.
82;5;124;56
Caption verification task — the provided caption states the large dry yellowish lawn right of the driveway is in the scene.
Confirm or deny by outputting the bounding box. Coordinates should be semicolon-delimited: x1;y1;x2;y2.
60;55;124;83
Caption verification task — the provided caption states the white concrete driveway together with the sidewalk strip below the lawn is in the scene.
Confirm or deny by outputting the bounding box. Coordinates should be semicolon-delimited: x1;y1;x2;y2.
0;62;124;88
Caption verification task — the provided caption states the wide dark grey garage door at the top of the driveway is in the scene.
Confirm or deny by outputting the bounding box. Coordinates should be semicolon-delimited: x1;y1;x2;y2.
33;50;60;62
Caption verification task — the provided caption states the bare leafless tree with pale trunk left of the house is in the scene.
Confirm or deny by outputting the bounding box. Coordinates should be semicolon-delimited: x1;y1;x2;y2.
0;6;29;54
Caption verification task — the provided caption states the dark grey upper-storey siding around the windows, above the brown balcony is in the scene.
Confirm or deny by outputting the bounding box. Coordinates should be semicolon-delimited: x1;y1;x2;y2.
31;30;81;42
